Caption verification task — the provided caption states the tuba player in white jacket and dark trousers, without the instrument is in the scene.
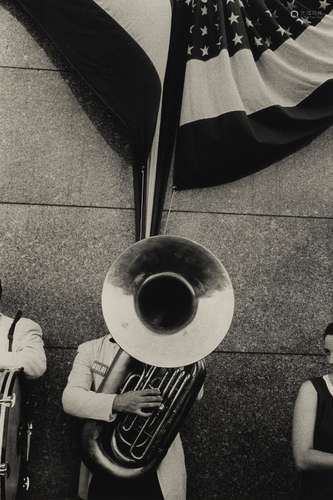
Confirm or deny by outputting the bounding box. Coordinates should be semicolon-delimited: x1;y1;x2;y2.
62;335;197;500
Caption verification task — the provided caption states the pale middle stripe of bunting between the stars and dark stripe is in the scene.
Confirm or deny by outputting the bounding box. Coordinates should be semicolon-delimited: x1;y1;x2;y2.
180;15;333;125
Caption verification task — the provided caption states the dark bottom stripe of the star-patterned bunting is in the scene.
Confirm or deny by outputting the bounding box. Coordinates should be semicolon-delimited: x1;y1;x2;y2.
174;79;333;189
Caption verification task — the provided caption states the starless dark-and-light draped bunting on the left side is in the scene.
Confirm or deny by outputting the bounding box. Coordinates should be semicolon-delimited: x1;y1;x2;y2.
18;0;171;166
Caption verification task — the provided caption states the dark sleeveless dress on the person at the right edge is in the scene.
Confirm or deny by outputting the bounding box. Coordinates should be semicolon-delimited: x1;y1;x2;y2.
299;377;333;500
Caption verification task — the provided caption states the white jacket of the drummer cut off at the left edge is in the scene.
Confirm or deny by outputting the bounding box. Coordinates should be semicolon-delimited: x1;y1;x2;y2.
0;314;46;378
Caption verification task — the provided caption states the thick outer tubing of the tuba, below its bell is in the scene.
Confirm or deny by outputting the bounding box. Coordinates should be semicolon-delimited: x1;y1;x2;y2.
81;348;206;479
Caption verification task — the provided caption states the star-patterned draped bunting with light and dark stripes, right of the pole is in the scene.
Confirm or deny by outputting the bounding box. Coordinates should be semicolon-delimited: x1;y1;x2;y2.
170;0;333;189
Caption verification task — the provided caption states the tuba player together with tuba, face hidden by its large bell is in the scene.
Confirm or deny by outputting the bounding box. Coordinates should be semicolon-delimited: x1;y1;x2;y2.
63;236;234;500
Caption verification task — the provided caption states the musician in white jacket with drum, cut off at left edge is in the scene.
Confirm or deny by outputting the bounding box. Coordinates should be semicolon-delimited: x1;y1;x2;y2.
0;280;46;500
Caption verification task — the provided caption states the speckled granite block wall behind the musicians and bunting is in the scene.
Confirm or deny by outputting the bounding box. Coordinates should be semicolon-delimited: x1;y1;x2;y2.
0;0;333;500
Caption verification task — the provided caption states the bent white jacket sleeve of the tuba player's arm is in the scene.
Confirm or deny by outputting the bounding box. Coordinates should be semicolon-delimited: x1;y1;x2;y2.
62;342;116;422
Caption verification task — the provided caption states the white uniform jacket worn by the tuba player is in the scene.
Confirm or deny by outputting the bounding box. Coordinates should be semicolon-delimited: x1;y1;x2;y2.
62;335;186;500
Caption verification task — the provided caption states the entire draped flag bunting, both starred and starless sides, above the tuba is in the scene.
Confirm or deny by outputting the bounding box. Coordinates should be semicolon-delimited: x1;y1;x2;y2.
17;0;333;225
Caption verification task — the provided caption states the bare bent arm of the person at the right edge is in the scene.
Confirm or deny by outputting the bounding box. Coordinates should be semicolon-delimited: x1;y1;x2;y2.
292;381;333;470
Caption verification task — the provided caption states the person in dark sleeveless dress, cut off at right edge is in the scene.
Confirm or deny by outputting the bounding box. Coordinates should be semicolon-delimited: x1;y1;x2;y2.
292;323;333;500
